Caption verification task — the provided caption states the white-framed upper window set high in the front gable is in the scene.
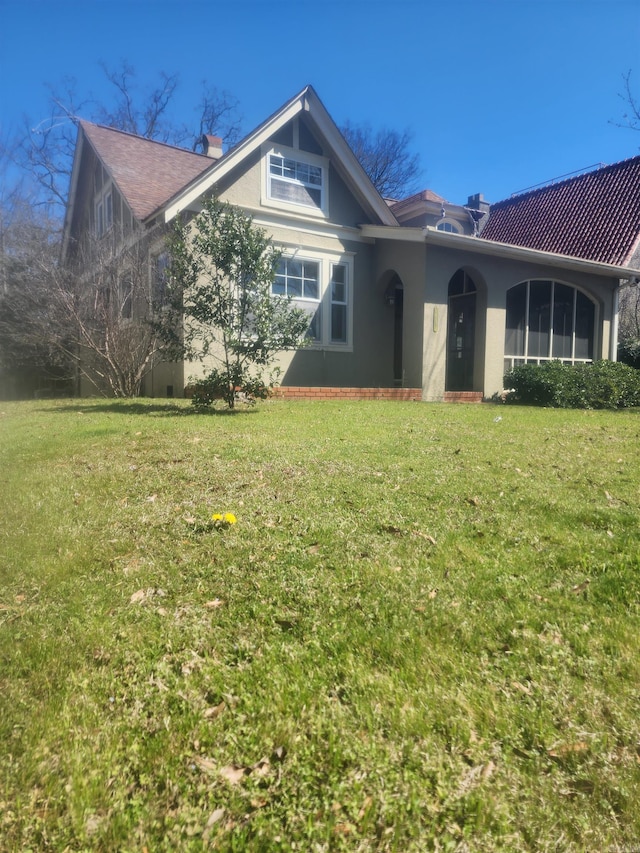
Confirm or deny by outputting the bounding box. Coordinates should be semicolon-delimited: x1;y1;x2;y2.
263;147;328;216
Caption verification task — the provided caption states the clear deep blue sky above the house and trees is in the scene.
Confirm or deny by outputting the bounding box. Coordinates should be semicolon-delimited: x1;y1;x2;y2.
0;0;640;203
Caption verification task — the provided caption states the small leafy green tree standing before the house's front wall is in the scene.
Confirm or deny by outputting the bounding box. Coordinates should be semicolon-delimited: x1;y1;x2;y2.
170;198;309;409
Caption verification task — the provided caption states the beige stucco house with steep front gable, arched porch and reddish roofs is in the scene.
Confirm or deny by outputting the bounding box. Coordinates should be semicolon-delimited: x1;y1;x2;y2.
65;87;640;400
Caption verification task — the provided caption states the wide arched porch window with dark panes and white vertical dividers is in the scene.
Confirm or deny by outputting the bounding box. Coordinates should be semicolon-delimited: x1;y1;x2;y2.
504;279;595;370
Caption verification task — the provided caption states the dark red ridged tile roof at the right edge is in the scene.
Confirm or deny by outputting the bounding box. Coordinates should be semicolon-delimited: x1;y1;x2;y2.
481;157;640;266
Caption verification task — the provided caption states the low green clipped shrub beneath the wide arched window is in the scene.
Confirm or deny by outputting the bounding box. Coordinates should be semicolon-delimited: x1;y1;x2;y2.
504;361;640;409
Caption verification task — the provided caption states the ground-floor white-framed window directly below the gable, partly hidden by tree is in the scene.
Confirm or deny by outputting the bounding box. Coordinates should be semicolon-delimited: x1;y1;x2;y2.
271;256;351;348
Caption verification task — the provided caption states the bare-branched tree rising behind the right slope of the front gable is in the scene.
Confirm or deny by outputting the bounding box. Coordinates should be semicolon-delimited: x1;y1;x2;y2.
340;122;421;199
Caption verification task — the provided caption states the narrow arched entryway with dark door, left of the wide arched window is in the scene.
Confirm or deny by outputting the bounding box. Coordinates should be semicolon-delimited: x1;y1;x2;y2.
445;269;478;391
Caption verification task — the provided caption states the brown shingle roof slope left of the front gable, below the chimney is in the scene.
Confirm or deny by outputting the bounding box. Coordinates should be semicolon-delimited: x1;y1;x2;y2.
81;122;216;221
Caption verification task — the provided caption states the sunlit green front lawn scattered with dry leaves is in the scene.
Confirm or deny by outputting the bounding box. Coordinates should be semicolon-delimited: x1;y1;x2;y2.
0;401;640;853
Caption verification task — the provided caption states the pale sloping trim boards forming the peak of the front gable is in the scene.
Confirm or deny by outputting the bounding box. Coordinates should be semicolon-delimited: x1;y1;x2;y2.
165;86;397;225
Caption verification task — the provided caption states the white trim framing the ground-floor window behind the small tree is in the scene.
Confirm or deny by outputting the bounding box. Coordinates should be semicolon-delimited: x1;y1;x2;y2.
274;248;354;352
